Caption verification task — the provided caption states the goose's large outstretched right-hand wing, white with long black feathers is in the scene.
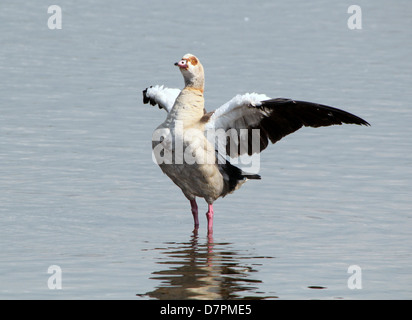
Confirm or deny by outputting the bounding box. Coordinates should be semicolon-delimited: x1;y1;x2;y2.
205;93;369;158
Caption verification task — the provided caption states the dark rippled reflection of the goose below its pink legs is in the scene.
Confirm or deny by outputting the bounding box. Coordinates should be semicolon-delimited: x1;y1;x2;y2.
139;230;277;300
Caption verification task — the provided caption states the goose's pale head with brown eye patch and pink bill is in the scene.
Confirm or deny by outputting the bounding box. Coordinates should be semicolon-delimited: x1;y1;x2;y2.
175;53;205;92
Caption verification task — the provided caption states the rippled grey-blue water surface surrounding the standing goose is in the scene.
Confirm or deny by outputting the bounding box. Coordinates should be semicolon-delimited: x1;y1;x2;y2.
0;0;412;299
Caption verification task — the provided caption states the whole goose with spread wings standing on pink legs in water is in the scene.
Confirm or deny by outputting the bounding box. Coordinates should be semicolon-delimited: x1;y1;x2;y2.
143;53;370;235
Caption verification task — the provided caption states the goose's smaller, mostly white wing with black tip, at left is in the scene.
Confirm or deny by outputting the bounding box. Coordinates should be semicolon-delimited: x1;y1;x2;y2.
143;85;180;112
